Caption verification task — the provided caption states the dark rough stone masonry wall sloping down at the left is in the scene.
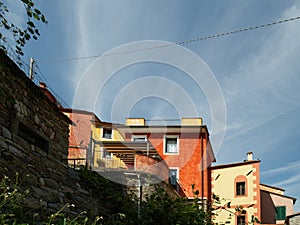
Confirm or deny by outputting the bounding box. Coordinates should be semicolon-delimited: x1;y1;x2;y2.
0;51;108;220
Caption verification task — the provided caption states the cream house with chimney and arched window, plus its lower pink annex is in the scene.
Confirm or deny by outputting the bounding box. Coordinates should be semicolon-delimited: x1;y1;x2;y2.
212;152;296;225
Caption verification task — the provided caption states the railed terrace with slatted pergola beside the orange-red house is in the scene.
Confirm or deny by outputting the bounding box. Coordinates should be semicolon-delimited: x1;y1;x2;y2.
68;139;169;182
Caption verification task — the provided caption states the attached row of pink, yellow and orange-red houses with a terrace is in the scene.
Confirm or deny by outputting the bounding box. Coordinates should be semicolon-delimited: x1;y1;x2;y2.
61;109;215;201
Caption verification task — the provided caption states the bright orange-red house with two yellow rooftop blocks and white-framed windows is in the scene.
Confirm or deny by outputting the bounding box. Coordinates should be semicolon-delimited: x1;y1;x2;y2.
116;118;215;200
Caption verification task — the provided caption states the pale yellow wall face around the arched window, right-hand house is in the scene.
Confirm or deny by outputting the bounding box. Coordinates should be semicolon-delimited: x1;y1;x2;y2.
212;164;257;224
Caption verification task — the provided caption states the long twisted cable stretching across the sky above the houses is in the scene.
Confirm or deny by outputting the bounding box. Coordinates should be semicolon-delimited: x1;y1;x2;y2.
37;16;300;62
